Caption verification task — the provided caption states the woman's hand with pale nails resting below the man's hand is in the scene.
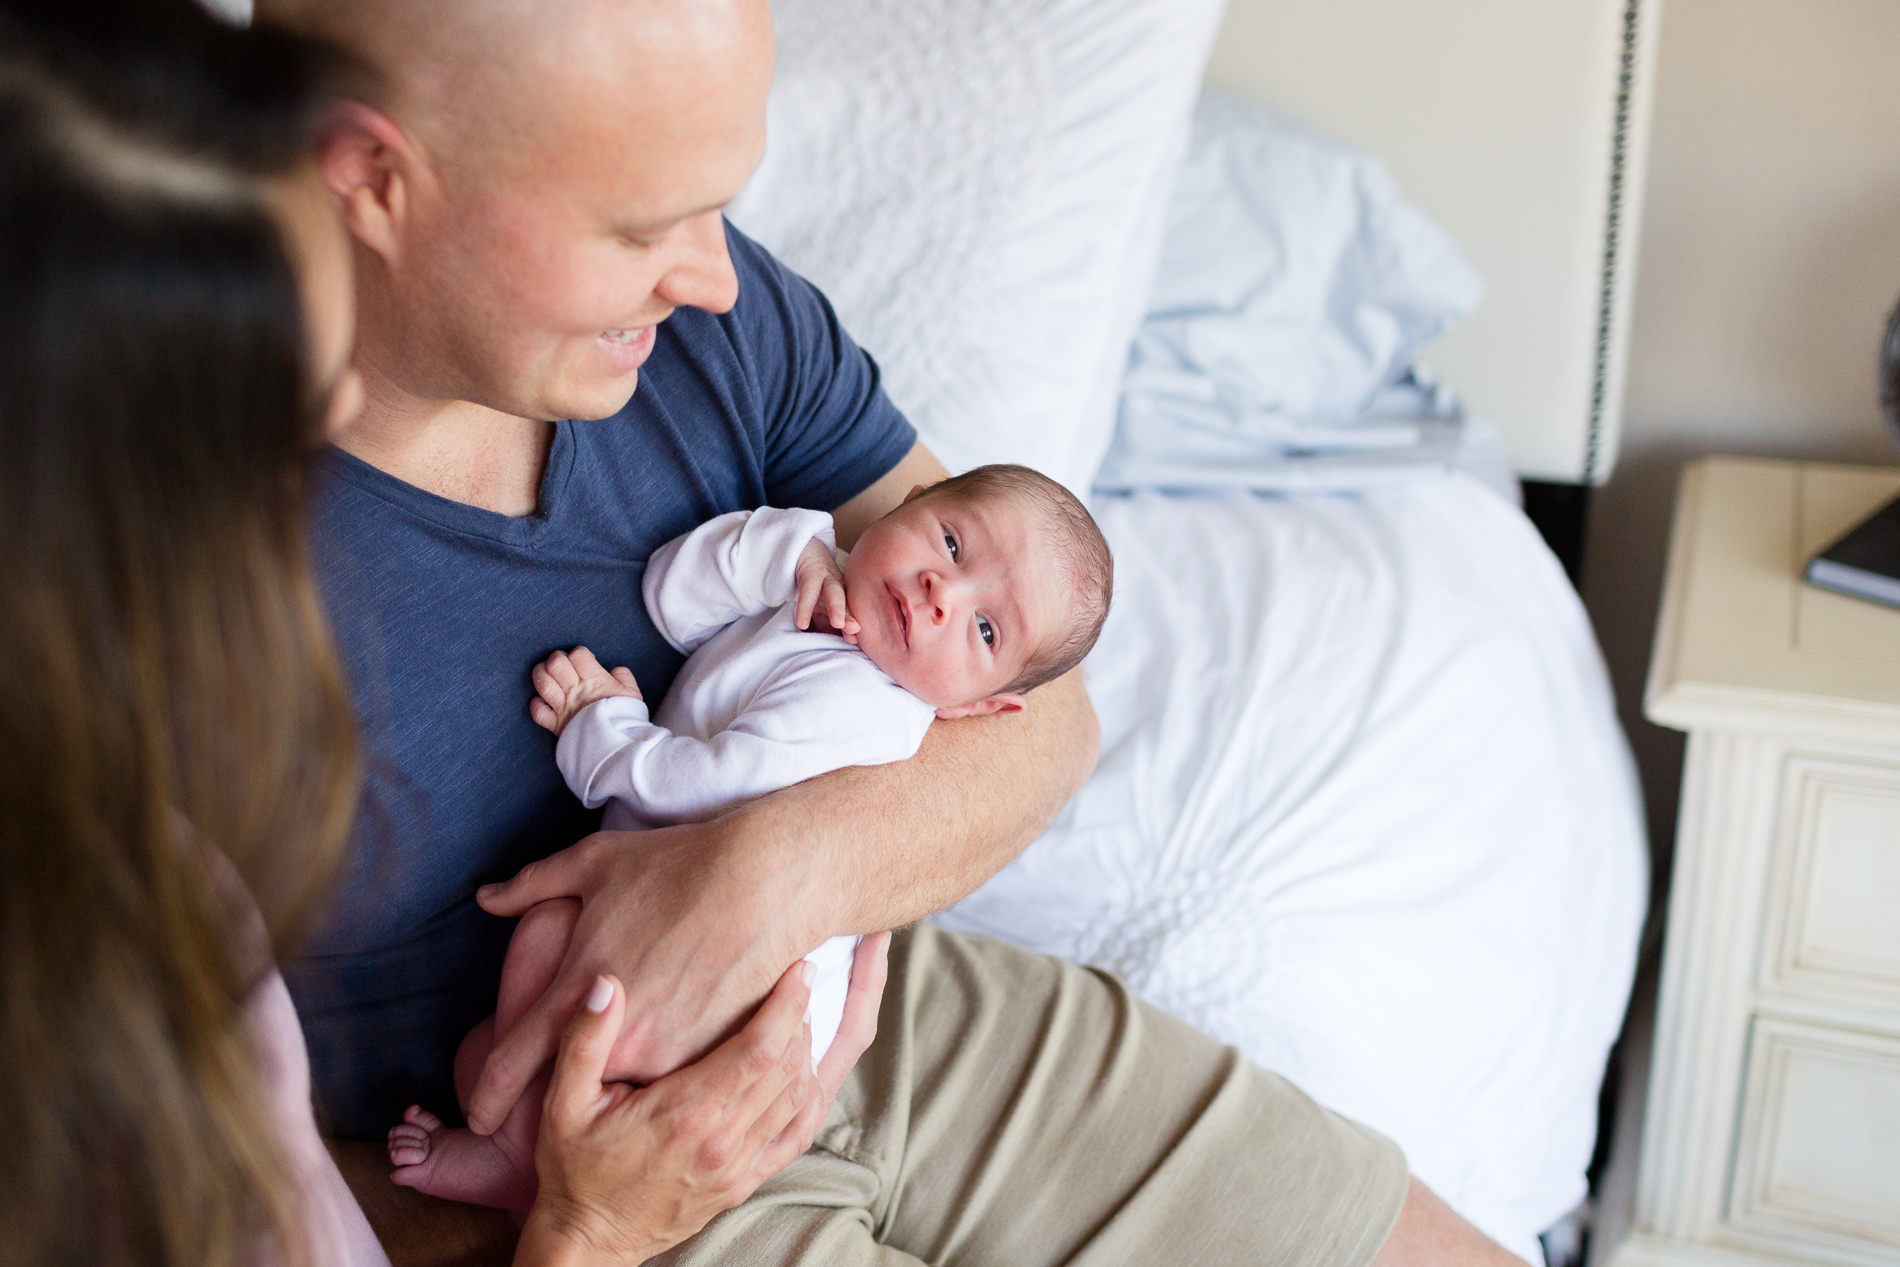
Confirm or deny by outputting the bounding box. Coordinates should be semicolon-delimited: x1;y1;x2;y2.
515;933;889;1267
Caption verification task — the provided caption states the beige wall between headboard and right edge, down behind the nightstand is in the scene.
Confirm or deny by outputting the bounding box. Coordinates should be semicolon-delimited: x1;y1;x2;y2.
1585;0;1900;862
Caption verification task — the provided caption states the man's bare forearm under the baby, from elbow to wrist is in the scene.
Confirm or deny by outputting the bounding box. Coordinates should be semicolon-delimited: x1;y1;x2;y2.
726;669;1100;933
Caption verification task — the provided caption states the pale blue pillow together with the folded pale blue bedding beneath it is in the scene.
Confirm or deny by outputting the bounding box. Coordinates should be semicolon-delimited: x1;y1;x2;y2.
1096;93;1516;501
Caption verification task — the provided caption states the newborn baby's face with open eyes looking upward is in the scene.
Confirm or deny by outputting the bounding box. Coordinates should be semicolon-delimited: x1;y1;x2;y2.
844;494;1062;714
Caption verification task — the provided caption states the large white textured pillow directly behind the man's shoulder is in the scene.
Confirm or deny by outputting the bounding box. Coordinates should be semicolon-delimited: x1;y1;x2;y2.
732;0;1222;492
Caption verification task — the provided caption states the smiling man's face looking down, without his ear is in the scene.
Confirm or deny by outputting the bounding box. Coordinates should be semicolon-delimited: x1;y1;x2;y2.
363;2;773;420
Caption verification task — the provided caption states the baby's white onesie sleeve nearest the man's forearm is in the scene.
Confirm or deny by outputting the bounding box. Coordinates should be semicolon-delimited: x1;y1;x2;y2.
555;650;937;824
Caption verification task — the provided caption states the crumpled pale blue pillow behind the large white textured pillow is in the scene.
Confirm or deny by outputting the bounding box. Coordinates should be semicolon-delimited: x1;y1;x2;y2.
1129;91;1484;424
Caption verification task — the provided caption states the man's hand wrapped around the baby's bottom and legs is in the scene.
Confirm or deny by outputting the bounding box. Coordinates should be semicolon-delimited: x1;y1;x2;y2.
467;821;859;1134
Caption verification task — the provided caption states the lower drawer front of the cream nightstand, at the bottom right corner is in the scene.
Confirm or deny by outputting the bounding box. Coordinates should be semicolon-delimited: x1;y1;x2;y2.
1725;1016;1900;1265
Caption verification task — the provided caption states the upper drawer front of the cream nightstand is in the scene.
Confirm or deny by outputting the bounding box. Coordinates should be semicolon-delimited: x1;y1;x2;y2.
1765;752;1900;1005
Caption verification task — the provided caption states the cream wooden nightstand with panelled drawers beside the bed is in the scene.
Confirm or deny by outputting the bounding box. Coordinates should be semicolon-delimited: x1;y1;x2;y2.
1613;458;1900;1267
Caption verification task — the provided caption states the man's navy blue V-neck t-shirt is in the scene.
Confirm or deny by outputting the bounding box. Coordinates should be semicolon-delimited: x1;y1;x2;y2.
292;228;916;1138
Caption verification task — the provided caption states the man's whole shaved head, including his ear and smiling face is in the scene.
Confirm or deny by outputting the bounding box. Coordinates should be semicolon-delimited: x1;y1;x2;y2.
257;0;773;418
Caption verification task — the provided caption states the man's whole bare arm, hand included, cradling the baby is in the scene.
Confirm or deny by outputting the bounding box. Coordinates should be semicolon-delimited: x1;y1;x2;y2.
467;444;1100;1130
